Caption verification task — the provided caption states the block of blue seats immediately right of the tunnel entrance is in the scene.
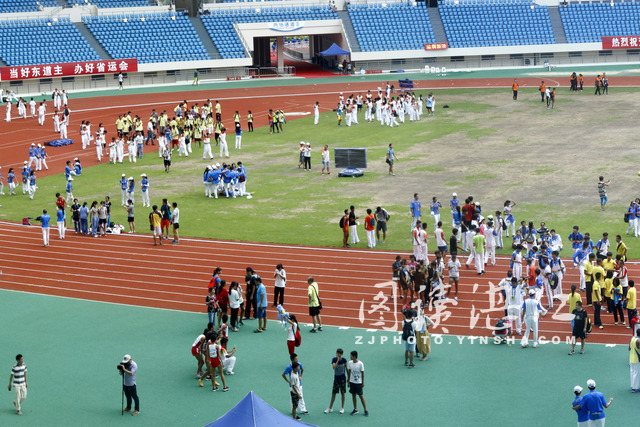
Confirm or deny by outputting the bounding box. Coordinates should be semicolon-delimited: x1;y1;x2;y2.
348;3;435;52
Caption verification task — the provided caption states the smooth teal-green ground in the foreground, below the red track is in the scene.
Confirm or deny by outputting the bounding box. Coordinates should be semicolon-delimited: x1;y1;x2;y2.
0;290;640;427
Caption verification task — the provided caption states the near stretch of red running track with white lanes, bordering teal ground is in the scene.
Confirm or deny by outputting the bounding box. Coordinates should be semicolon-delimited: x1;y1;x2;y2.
0;222;640;344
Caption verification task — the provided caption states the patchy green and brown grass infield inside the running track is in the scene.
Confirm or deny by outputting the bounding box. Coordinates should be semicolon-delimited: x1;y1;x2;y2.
0;89;640;258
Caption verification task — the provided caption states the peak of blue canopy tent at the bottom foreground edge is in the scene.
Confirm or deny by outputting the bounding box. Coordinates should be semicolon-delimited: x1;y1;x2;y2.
205;391;313;427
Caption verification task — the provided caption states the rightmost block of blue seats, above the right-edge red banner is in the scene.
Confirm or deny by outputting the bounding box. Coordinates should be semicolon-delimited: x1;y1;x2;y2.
559;2;640;47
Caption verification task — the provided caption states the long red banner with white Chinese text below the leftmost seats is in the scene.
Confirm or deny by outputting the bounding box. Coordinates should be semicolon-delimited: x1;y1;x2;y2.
0;59;138;81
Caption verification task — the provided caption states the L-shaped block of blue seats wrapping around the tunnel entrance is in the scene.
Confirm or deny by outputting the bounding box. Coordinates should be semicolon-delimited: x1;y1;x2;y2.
201;6;338;59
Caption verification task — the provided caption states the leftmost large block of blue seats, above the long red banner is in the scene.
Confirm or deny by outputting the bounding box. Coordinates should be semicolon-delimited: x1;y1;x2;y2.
0;18;100;66
